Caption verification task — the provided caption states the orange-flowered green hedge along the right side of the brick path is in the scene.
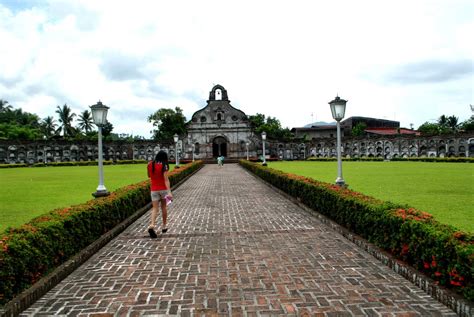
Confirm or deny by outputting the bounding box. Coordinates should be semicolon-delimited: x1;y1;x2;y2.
240;160;474;301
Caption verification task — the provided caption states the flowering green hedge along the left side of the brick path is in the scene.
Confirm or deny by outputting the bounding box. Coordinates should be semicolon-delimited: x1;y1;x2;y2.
0;161;202;304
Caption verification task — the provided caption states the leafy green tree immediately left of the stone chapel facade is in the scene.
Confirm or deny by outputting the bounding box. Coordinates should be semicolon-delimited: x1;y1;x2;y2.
148;107;186;142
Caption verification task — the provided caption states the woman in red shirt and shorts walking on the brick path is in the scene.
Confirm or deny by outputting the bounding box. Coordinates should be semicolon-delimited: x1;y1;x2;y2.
147;151;173;238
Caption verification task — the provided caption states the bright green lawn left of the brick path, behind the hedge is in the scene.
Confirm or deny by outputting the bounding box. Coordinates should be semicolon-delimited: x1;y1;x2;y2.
0;164;173;232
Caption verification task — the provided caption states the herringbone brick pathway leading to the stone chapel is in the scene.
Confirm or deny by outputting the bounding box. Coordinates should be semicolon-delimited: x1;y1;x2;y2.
23;164;455;316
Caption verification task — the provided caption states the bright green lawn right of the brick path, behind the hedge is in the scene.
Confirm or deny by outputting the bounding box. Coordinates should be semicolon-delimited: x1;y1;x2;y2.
268;161;474;232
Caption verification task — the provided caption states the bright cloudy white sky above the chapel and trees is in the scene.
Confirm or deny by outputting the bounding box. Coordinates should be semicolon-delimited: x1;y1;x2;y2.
0;0;474;137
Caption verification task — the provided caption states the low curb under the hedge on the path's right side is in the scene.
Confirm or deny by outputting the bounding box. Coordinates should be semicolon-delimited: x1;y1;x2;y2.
243;165;474;317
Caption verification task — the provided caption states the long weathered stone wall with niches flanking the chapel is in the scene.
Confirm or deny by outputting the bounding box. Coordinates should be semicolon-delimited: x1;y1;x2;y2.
0;133;474;164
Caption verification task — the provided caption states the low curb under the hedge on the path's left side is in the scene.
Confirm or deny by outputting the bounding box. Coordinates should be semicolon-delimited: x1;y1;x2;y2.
0;165;203;317
